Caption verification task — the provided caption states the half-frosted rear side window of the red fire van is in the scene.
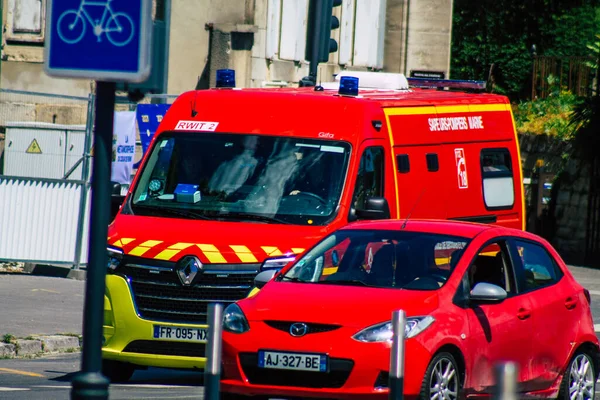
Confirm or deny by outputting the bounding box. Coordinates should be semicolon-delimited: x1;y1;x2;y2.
481;148;515;209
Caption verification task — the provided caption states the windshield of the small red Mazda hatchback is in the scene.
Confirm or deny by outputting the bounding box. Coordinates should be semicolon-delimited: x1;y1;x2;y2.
278;230;469;290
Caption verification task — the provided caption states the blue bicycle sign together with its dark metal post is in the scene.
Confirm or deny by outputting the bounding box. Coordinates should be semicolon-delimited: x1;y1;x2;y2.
44;0;152;399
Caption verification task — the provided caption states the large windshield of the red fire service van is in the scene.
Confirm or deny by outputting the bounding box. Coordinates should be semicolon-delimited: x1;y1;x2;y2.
131;132;350;225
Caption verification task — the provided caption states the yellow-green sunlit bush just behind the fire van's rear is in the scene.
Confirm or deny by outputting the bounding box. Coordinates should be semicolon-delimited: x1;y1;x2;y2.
514;76;584;140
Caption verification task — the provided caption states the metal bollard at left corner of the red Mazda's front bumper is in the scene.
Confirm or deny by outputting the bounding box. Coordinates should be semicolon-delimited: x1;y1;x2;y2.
204;304;223;400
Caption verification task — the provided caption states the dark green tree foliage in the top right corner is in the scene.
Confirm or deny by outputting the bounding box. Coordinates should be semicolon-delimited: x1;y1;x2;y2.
450;0;600;101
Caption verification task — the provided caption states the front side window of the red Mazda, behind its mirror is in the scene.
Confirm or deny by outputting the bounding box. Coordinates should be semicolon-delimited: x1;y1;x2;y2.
468;241;516;295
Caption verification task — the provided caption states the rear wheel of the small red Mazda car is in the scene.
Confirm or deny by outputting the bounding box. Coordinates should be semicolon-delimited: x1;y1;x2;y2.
558;350;598;400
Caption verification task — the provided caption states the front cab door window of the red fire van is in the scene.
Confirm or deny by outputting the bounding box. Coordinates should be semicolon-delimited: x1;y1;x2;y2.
352;147;383;210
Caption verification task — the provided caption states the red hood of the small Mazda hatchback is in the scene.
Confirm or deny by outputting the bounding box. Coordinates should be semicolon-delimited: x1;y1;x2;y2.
238;281;438;328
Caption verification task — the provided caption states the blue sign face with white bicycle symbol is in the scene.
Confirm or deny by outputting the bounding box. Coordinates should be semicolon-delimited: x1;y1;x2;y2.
47;0;147;78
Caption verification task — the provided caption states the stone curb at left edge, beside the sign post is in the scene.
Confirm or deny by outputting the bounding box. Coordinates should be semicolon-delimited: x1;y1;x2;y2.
0;335;81;359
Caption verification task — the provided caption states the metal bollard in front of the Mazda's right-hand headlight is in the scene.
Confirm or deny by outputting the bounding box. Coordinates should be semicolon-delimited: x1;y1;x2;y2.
389;310;406;400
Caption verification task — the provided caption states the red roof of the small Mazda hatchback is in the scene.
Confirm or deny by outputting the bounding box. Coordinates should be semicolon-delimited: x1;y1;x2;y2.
341;219;496;239
